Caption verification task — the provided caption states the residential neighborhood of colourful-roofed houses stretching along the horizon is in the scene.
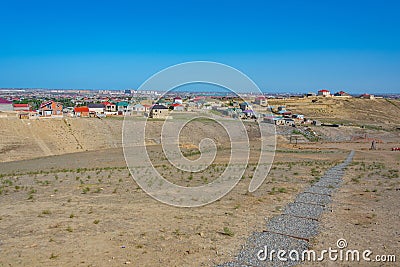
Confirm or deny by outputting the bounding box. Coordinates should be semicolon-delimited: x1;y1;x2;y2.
0;89;394;131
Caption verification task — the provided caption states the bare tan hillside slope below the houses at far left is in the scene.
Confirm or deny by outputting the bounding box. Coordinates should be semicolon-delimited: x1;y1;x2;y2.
0;117;122;161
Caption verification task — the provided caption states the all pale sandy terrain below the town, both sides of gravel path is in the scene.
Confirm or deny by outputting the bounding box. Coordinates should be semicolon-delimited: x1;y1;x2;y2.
0;100;400;266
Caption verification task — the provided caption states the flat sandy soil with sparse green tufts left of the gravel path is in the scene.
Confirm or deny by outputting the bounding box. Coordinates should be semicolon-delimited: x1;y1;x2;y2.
0;147;345;266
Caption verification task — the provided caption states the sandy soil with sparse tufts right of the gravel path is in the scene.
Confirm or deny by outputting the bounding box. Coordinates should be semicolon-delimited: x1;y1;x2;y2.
309;148;400;266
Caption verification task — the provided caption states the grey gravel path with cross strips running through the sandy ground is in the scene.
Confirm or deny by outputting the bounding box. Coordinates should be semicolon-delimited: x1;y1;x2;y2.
219;151;354;267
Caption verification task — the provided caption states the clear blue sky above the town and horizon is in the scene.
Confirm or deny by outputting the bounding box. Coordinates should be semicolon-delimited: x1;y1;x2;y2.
0;0;400;93
